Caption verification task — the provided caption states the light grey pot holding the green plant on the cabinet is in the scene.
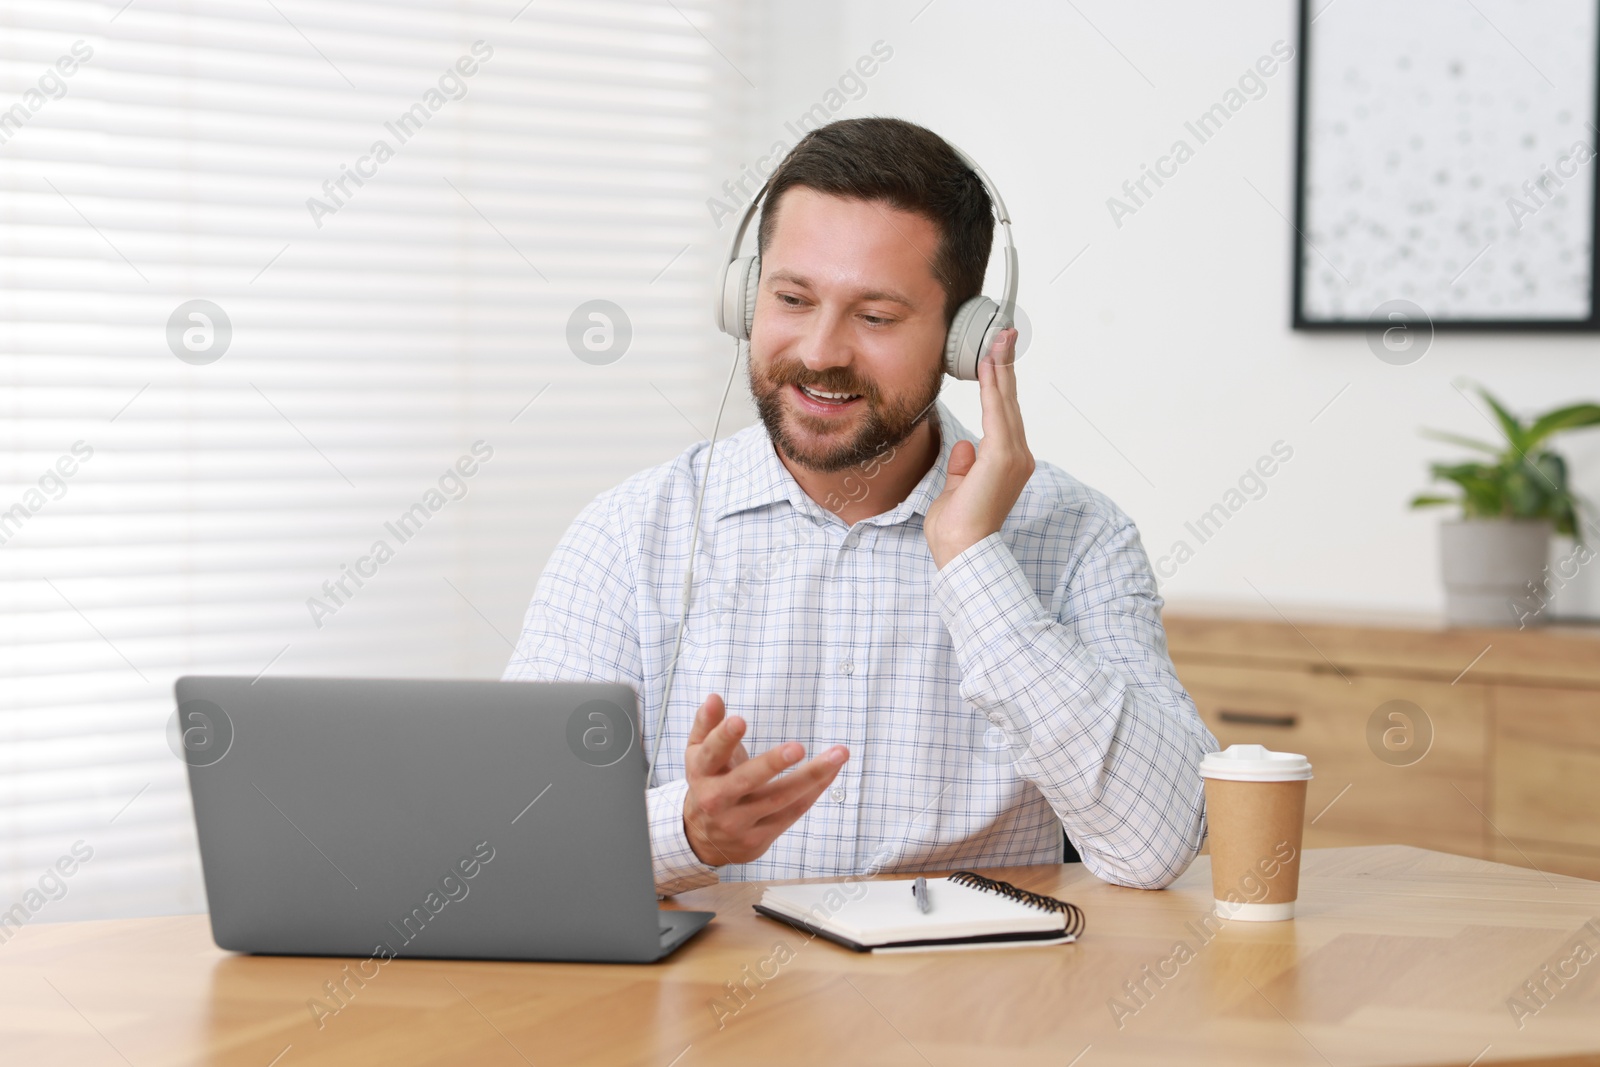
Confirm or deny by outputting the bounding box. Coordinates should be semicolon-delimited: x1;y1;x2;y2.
1438;518;1554;629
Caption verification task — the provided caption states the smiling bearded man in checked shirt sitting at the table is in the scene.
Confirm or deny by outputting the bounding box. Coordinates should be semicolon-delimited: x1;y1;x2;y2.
506;118;1216;894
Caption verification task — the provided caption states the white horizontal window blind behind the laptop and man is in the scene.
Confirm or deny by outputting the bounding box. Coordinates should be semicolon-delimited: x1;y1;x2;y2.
0;0;744;921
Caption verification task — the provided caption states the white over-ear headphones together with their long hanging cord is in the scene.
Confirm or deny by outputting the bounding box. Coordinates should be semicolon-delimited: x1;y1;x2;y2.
645;137;1018;789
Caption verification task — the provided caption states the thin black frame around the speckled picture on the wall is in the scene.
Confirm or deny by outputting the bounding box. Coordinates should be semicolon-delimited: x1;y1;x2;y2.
1290;0;1600;333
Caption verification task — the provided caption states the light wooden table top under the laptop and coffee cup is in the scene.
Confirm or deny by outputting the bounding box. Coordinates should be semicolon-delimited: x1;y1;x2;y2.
0;846;1600;1067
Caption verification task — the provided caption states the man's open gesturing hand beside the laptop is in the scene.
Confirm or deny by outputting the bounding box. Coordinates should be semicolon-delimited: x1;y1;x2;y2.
683;693;850;867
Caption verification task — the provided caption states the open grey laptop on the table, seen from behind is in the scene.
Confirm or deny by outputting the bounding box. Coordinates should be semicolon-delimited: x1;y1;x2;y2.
173;677;712;963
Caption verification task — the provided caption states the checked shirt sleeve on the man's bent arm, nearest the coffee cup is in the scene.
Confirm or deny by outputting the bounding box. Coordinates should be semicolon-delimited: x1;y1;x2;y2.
933;518;1216;889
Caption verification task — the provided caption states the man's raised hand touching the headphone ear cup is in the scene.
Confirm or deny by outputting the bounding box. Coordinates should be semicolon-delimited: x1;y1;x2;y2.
923;328;1034;569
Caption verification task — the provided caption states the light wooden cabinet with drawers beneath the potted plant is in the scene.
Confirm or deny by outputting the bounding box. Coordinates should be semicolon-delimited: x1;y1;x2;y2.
1166;611;1600;878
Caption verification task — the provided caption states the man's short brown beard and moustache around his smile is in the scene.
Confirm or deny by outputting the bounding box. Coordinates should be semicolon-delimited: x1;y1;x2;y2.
750;348;944;474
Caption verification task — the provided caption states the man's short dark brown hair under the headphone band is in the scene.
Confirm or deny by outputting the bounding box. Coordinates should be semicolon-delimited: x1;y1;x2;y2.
755;118;995;326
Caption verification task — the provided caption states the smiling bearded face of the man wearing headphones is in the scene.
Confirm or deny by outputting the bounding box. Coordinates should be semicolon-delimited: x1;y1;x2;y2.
750;186;944;474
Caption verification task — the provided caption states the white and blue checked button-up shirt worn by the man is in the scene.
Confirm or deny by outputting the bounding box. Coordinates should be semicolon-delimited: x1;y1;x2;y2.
504;403;1216;894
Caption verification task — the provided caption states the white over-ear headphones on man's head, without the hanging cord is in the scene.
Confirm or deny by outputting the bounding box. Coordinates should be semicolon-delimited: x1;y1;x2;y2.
714;144;1018;382
